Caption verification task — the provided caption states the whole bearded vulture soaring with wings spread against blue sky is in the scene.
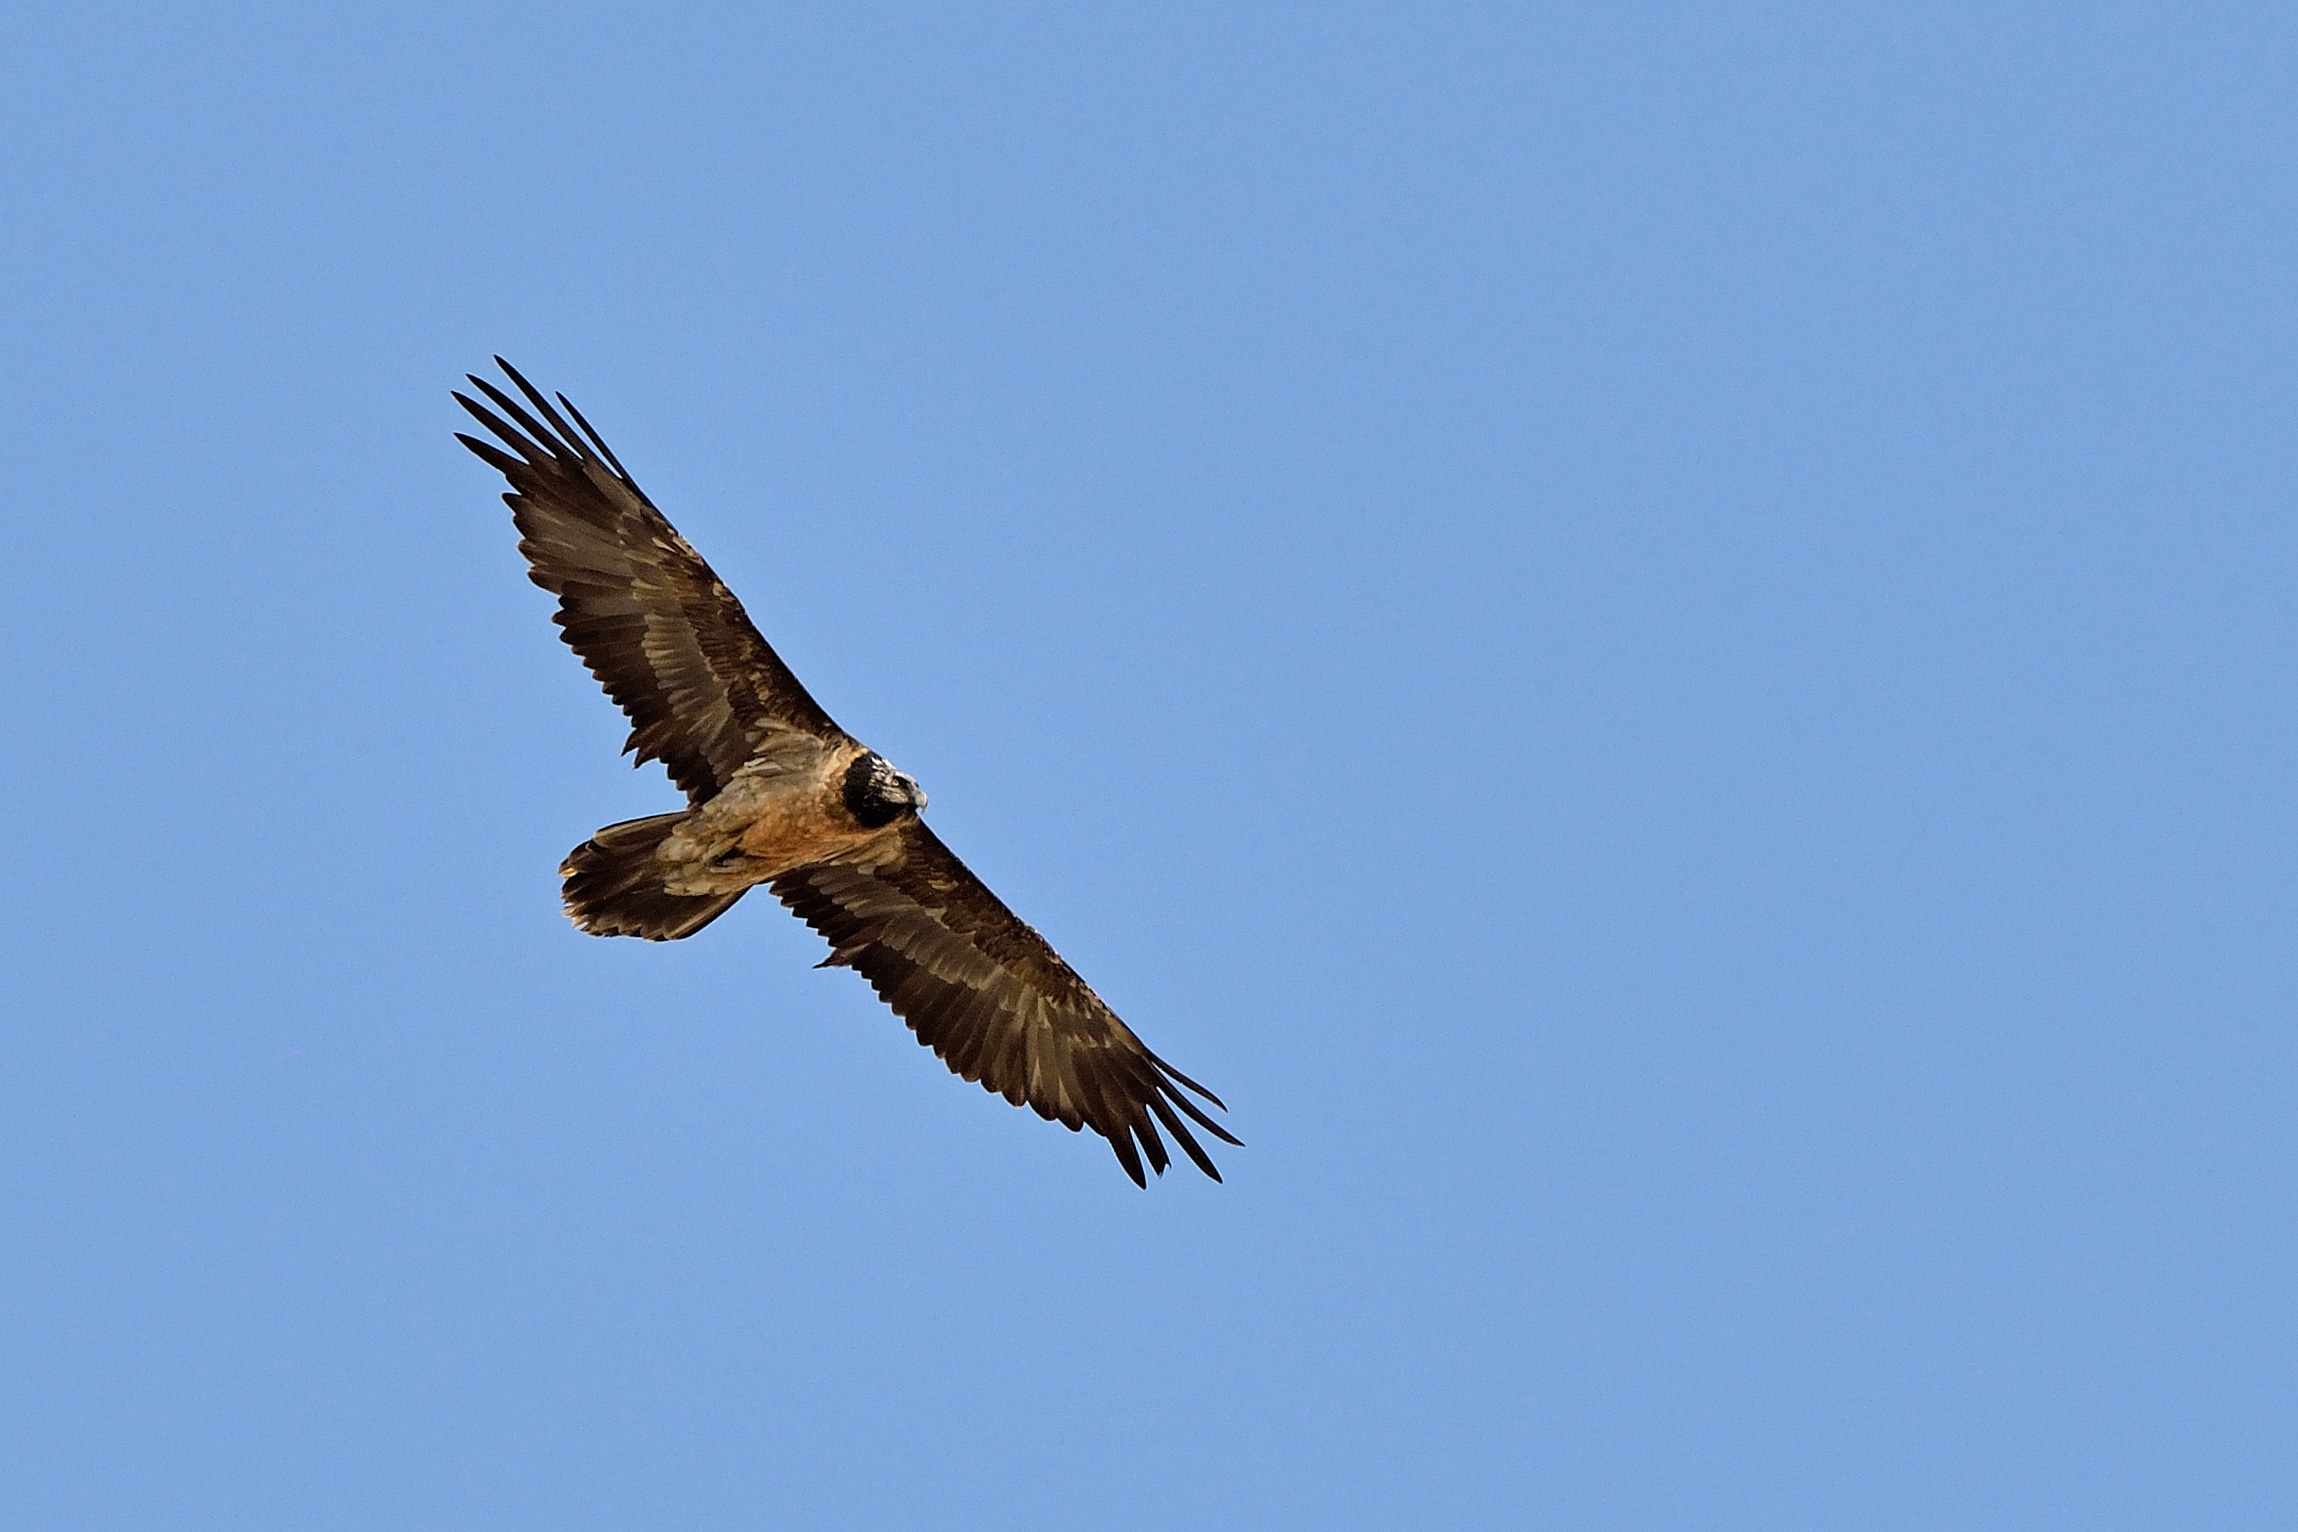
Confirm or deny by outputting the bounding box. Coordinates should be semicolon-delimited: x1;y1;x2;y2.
455;356;1239;1185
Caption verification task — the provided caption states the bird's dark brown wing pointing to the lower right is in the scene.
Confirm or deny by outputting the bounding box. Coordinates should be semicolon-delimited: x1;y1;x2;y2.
770;820;1236;1185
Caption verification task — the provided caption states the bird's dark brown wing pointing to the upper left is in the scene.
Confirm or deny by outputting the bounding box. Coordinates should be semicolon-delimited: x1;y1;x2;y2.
455;356;843;804
